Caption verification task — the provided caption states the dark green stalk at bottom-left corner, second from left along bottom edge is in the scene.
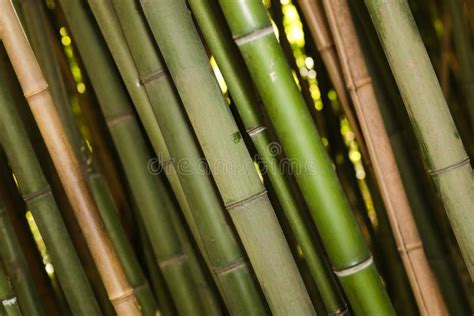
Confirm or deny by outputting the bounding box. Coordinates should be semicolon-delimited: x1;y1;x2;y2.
0;196;45;316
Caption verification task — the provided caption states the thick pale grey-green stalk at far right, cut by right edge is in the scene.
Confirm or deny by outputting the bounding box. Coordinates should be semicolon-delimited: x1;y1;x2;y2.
365;0;474;279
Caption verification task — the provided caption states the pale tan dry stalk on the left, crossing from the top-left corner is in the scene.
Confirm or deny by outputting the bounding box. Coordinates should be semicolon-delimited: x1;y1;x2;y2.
0;0;141;316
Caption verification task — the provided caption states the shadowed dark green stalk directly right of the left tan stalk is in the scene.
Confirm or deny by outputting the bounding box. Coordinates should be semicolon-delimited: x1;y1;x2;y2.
20;0;157;315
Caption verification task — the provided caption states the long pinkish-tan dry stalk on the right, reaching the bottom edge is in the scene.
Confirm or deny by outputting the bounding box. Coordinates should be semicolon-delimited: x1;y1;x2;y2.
323;0;448;315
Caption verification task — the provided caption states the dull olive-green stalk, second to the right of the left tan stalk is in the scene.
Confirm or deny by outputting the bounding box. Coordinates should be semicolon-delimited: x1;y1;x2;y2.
55;0;209;314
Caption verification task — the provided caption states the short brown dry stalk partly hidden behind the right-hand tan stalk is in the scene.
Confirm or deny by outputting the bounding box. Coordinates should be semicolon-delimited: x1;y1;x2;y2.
298;0;370;163
